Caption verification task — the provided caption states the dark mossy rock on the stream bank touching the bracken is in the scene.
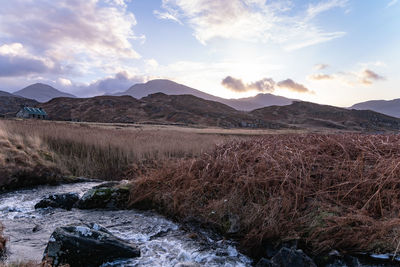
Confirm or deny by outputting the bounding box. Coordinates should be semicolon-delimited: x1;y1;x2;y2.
76;187;129;209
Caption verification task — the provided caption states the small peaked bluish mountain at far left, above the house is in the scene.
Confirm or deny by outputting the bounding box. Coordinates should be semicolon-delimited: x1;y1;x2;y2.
14;83;76;102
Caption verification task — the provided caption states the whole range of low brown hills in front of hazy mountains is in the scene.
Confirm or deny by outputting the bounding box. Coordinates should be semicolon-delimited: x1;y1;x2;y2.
40;93;400;132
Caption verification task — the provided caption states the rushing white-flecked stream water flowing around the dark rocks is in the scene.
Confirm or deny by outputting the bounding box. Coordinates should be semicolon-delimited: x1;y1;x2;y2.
0;183;251;266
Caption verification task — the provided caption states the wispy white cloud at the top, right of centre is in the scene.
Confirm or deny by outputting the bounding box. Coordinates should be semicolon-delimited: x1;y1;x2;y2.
155;0;347;50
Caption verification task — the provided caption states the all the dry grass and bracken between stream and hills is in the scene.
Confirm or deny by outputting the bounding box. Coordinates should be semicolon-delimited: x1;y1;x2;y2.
0;121;400;264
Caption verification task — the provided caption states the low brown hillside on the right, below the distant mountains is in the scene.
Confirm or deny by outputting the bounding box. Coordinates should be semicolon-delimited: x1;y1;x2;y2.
250;101;400;131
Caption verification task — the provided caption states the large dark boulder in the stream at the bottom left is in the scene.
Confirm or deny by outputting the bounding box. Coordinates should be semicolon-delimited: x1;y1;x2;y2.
43;223;140;267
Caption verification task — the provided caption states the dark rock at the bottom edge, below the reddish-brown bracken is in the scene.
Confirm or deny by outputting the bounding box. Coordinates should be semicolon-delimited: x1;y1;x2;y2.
271;247;317;267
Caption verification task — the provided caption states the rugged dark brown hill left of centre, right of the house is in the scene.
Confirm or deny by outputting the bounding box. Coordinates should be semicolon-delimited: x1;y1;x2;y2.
40;93;286;128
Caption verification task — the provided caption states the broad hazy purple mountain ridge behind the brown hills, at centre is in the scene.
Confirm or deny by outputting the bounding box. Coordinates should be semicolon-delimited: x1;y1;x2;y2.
114;79;293;111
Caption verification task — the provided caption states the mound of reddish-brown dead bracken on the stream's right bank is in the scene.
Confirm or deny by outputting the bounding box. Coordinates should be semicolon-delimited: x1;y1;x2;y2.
131;134;400;256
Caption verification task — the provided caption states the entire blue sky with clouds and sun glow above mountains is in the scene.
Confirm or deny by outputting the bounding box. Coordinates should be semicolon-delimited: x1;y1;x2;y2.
0;0;400;107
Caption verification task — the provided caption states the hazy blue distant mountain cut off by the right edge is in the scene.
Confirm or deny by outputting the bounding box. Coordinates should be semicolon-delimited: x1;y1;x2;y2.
351;98;400;118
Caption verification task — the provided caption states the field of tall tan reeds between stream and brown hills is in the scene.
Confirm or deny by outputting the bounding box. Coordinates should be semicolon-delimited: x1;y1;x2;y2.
3;120;230;180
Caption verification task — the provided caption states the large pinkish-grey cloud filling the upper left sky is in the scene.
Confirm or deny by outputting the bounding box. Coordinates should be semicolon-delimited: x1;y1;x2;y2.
0;0;140;78
